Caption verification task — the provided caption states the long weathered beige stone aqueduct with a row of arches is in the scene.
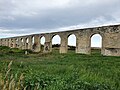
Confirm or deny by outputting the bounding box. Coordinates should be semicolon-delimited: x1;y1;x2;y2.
0;25;120;56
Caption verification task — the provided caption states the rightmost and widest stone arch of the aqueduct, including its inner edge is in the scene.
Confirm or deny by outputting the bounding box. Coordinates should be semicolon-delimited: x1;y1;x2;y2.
90;33;103;53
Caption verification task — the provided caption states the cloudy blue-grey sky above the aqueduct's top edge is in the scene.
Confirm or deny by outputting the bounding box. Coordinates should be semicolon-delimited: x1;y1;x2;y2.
0;0;120;46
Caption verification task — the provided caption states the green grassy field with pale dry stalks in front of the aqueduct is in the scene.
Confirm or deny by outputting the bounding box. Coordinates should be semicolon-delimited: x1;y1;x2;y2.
0;46;120;90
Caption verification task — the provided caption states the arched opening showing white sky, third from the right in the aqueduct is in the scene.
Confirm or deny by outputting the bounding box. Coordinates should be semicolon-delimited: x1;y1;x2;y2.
52;35;61;51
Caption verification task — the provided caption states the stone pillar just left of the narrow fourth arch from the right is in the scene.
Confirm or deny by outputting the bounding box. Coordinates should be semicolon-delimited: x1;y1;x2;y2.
33;35;40;52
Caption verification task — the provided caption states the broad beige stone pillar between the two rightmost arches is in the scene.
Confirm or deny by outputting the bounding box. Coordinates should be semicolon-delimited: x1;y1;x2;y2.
76;32;91;54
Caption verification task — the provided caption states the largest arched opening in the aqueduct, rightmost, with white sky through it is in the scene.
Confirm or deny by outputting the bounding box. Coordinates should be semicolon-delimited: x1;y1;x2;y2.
90;34;102;53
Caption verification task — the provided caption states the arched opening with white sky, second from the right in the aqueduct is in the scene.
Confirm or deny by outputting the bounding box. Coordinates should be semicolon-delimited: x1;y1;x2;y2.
68;34;76;51
